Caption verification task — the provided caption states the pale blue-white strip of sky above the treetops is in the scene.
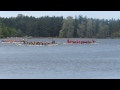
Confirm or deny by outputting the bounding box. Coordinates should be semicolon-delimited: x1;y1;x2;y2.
0;11;120;19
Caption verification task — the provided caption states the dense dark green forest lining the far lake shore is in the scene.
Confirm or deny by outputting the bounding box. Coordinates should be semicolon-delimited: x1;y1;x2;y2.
0;14;120;38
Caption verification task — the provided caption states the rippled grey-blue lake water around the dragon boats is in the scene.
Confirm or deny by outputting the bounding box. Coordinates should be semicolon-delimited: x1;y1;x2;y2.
0;38;120;79
